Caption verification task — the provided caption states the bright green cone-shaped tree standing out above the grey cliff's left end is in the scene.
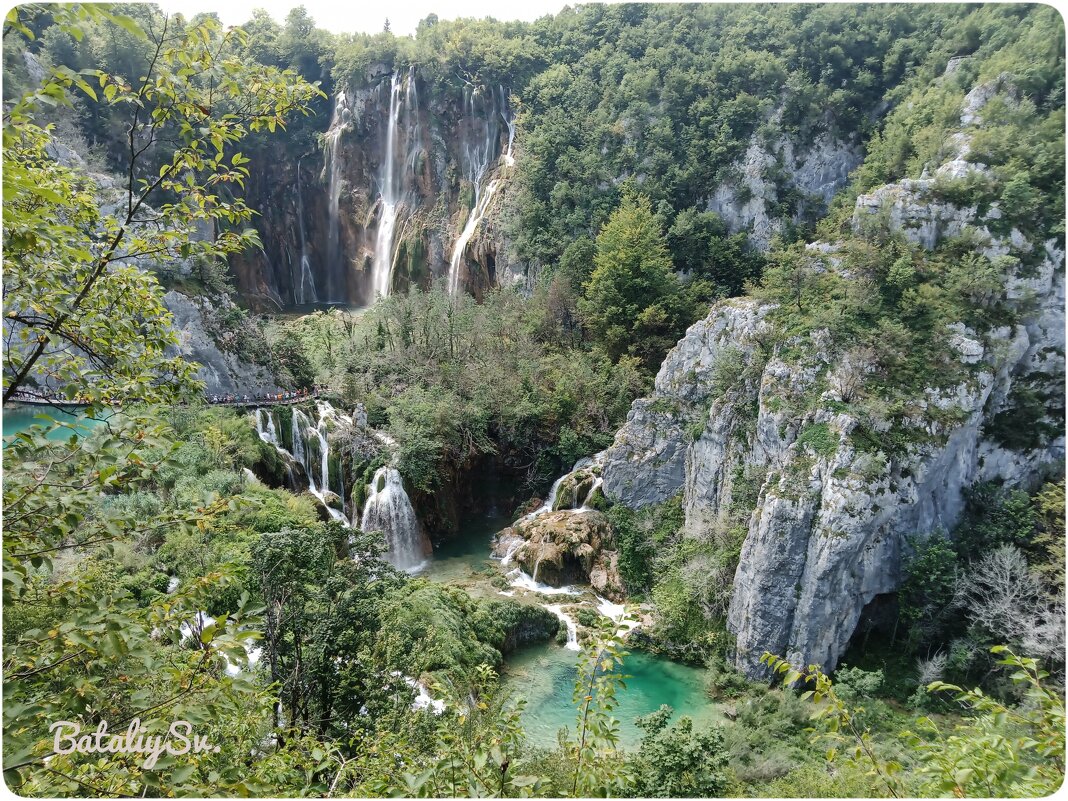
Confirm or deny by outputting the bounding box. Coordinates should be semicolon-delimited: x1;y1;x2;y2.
579;195;680;367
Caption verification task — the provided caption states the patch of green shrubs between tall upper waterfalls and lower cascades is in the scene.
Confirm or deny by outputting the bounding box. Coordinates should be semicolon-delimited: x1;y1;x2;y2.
286;284;645;501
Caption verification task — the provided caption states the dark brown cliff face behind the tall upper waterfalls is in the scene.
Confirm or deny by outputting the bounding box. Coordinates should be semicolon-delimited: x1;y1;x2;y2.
233;65;521;308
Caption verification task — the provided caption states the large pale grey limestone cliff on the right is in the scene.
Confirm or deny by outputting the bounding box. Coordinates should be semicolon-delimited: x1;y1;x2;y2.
602;76;1065;675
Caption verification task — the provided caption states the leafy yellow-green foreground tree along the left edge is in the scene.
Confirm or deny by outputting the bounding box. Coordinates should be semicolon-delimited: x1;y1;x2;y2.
3;5;316;796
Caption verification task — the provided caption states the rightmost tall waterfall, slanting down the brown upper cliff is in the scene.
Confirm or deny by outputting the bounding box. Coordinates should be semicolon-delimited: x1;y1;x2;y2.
449;87;516;295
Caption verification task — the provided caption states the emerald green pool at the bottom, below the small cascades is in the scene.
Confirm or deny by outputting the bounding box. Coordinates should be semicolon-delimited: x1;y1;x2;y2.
504;645;722;749
